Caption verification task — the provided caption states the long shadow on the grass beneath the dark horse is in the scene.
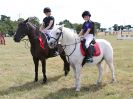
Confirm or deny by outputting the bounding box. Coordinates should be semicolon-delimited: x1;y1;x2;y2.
0;74;63;96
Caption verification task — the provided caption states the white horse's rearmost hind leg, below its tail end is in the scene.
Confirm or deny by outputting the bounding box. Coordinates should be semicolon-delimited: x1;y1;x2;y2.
105;59;116;83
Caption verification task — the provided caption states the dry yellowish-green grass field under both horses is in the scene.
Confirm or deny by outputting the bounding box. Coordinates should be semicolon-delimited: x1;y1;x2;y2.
0;36;133;99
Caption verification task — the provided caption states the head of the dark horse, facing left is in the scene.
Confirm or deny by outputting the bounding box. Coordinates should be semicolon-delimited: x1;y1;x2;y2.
14;18;29;42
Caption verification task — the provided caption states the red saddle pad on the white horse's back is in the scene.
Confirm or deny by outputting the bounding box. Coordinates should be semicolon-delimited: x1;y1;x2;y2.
80;39;100;57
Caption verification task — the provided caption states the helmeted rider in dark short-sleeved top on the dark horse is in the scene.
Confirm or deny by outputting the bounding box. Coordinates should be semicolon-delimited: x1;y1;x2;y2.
39;7;58;56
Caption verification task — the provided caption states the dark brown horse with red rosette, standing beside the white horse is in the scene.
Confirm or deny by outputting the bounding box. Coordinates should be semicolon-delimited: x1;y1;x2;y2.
14;19;70;83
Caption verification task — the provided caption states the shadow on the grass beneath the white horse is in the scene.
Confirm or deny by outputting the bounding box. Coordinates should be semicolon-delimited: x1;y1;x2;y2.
43;84;106;99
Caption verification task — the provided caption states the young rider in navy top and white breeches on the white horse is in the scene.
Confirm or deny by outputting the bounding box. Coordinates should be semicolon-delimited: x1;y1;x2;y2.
79;11;95;62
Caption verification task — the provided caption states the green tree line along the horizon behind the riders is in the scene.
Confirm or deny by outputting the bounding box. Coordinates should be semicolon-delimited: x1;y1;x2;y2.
0;15;131;36
